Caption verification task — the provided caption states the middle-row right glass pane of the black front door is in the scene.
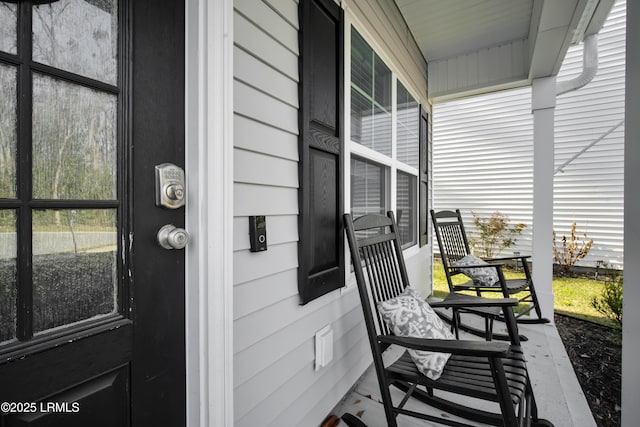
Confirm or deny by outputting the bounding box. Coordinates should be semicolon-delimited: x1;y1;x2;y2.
33;74;117;200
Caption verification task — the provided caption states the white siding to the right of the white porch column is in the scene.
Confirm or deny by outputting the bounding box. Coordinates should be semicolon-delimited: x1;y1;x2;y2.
554;0;626;267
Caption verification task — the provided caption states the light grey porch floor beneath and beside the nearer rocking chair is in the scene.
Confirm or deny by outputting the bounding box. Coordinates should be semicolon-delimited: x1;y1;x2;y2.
332;310;596;427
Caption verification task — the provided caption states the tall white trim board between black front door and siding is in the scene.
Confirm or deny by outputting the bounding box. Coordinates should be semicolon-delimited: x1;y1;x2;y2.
185;0;233;427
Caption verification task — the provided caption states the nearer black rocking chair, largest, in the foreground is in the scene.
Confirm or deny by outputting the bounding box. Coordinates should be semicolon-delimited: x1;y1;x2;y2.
344;212;553;427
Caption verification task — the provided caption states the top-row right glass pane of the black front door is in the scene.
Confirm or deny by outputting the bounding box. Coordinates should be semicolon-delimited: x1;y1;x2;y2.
33;0;118;84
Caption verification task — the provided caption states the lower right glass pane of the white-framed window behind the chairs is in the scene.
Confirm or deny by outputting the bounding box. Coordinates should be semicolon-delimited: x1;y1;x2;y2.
396;171;418;247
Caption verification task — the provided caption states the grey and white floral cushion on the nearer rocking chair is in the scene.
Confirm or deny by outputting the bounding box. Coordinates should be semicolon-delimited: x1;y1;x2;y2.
378;287;454;380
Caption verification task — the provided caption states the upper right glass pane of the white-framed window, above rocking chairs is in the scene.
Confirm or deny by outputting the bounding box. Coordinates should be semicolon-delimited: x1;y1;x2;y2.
397;81;420;168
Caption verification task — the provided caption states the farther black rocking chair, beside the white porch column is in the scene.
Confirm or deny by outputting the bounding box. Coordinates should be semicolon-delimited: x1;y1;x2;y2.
431;209;549;323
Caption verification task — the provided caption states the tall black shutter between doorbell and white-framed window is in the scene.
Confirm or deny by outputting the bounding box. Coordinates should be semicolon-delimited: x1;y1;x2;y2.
298;0;344;304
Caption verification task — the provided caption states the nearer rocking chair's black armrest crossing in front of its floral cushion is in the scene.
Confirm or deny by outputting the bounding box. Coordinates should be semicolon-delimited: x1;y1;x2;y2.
378;335;510;357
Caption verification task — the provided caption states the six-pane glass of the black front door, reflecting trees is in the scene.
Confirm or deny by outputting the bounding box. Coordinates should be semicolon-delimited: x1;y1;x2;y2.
0;0;119;342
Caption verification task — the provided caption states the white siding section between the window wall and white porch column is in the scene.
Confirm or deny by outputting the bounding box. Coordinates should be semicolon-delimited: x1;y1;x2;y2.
433;88;533;255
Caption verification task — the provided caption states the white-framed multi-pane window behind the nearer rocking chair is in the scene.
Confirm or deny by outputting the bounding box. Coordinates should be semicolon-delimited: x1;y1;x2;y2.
345;24;420;249
